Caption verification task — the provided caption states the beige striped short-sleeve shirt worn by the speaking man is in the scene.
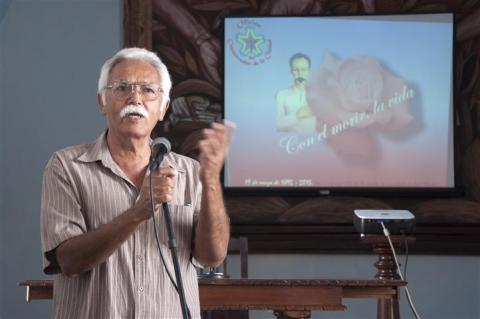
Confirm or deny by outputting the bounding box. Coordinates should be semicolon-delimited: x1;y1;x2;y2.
41;133;201;319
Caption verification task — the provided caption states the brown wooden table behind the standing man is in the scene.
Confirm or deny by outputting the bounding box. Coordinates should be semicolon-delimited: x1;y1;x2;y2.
20;279;406;319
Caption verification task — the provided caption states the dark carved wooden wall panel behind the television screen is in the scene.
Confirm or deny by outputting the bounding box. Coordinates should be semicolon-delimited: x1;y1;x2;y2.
124;0;480;253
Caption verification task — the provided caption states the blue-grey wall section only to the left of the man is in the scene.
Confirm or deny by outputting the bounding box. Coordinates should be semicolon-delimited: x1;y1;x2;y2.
0;0;122;318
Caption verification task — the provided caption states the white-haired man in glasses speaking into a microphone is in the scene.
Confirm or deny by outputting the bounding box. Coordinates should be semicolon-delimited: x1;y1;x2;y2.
41;48;229;319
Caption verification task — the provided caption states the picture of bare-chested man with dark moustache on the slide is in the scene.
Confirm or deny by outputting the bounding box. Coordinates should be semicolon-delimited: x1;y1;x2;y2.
276;53;316;133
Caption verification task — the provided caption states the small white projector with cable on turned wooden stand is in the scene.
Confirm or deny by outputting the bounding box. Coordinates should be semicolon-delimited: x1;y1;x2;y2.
353;209;415;235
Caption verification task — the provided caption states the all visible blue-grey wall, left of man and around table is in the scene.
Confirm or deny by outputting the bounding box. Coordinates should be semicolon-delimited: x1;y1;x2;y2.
0;0;480;319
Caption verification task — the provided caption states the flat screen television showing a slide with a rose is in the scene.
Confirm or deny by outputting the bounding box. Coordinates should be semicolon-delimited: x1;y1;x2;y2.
224;13;455;192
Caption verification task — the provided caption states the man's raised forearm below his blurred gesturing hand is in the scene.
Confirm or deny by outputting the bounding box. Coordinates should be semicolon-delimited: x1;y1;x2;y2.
194;178;230;267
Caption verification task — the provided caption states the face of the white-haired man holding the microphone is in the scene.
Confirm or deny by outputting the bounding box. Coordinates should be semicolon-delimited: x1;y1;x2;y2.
98;60;168;138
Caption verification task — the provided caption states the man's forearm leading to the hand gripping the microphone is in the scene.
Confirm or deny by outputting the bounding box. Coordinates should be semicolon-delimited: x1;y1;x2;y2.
56;208;143;276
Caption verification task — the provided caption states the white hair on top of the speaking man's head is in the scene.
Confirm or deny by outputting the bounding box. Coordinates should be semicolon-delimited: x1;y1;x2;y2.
97;48;172;104
